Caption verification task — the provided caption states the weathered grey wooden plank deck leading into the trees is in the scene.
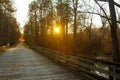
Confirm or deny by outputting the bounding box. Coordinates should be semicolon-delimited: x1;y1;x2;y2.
0;43;82;80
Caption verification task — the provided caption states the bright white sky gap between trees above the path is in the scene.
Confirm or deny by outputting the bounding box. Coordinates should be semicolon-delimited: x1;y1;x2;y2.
13;0;34;28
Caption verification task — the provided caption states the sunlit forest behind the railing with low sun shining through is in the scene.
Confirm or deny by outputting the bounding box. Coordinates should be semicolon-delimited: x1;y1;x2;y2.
24;0;120;62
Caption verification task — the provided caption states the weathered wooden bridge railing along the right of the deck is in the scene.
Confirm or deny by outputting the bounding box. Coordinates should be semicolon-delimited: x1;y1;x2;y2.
31;47;120;80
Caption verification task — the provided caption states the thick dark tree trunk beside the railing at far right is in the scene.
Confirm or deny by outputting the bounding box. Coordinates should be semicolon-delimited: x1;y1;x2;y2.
109;0;120;63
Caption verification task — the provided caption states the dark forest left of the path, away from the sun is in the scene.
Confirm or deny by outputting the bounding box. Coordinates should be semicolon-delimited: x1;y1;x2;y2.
0;0;20;46
